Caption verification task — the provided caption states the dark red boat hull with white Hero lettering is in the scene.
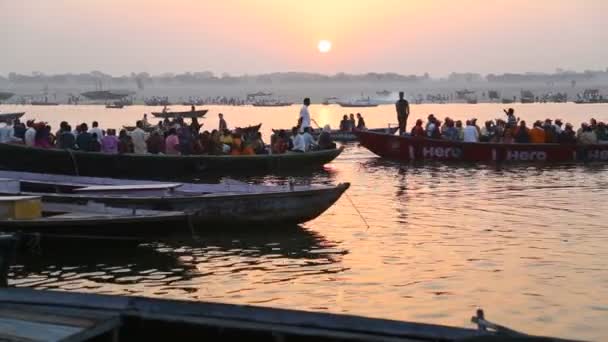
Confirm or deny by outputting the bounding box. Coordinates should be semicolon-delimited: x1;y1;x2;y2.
357;131;608;163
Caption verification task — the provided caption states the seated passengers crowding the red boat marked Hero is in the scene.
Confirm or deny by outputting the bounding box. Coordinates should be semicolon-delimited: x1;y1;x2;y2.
409;108;608;144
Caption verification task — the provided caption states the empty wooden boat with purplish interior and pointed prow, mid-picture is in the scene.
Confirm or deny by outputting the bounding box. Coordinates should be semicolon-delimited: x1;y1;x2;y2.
0;171;350;226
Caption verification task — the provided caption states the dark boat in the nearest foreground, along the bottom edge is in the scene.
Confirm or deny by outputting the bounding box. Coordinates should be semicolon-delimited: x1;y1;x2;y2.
0;288;564;342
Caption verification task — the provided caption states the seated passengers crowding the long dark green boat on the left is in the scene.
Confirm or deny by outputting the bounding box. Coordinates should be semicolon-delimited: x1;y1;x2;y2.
0;107;335;155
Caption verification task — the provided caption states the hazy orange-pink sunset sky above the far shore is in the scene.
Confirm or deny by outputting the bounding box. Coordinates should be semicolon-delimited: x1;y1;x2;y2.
0;0;608;76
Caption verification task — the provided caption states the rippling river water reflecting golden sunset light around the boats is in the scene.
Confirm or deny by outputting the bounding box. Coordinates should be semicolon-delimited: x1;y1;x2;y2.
0;104;608;340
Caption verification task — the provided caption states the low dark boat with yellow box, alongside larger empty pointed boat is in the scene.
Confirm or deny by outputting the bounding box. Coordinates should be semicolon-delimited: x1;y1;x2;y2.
0;196;188;235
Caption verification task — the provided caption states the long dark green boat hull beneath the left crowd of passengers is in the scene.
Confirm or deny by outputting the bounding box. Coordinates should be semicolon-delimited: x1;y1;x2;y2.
0;144;343;179
